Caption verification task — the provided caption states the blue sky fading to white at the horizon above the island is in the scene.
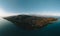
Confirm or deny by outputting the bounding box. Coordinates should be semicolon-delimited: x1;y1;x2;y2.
0;0;60;16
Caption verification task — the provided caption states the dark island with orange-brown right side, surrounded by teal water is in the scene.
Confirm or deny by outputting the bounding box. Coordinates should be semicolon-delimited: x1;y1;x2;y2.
4;15;57;30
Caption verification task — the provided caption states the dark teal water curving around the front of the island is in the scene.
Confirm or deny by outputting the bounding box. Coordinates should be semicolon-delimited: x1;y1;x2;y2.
0;19;60;36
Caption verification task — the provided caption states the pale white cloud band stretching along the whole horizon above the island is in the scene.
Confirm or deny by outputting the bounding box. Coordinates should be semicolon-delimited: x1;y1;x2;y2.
0;7;60;17
